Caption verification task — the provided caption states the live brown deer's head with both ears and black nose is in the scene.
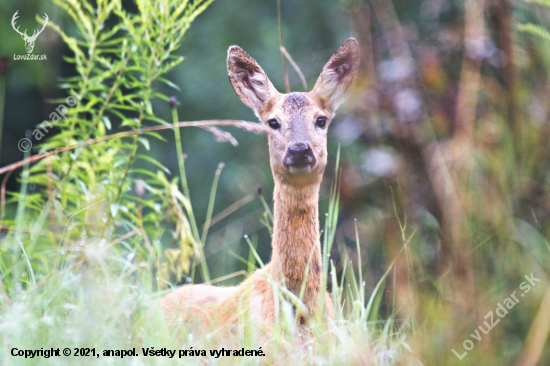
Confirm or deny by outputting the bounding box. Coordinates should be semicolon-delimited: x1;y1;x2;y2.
227;38;359;186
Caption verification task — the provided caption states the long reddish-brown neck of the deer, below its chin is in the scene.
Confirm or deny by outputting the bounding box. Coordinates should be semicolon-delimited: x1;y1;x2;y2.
269;180;322;302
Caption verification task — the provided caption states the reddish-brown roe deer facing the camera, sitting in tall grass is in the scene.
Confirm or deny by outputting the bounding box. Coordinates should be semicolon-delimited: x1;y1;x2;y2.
162;38;359;329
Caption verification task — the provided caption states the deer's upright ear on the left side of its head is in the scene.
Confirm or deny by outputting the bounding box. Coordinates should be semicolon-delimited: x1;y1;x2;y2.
227;46;278;115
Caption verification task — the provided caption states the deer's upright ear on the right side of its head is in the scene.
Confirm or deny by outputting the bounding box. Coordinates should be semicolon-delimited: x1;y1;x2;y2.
312;38;359;111
